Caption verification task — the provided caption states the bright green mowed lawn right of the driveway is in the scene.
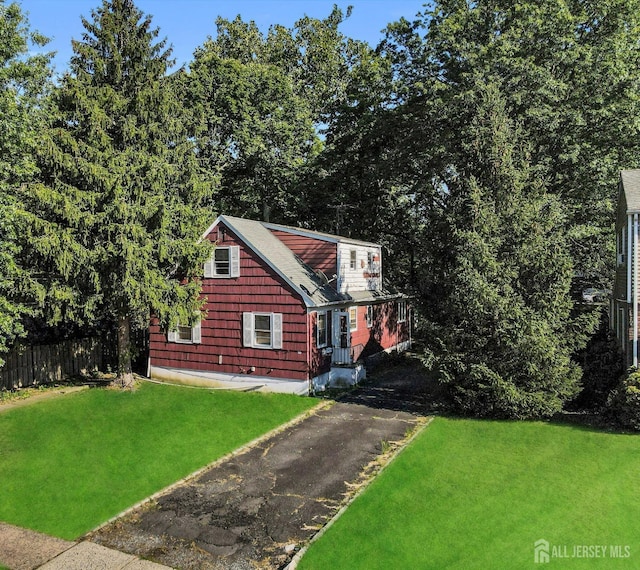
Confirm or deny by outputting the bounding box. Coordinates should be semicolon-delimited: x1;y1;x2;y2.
298;418;640;570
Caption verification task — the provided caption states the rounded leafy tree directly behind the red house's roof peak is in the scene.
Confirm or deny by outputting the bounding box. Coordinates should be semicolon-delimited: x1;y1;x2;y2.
181;26;316;220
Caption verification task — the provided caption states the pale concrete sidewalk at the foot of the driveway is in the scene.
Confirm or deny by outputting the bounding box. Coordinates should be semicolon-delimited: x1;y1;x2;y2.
0;523;168;570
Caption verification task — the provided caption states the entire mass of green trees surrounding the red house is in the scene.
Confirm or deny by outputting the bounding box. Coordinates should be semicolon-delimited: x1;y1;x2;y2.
0;0;640;410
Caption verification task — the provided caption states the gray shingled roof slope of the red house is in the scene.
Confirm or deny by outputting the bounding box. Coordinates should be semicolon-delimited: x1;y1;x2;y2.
218;216;400;307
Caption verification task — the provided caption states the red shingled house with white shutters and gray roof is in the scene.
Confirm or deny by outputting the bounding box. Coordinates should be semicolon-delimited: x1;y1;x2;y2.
149;216;411;394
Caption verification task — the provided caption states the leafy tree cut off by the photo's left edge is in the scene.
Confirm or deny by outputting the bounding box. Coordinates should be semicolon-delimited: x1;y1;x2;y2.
0;0;51;364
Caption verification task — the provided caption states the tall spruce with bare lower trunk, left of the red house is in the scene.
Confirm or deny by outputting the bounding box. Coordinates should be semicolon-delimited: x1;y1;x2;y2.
24;0;213;386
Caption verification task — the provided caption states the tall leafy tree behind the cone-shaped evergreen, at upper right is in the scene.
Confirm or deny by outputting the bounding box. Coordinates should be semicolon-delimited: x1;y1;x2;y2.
386;0;640;286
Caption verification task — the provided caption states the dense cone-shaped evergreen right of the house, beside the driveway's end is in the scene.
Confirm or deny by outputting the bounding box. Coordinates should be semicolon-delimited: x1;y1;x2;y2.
425;78;584;418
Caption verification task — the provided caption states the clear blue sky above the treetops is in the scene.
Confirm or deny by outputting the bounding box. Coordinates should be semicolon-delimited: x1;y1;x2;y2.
17;0;424;73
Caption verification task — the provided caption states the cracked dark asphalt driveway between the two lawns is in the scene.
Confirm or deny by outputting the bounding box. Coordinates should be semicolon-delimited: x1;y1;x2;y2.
87;358;427;570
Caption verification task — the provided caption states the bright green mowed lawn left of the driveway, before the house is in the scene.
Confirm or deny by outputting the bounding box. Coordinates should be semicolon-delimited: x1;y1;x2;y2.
0;383;317;539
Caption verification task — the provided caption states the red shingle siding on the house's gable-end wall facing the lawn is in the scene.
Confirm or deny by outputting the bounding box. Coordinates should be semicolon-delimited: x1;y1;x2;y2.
150;222;308;380
